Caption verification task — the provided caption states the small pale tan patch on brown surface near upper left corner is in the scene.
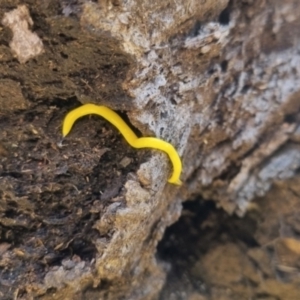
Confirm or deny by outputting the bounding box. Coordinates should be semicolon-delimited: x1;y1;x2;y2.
2;5;43;63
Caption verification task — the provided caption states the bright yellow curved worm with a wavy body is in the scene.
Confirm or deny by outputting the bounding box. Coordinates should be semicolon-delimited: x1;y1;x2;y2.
62;104;182;185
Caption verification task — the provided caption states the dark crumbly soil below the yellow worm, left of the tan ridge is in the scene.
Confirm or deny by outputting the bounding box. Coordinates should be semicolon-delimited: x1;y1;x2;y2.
0;102;146;299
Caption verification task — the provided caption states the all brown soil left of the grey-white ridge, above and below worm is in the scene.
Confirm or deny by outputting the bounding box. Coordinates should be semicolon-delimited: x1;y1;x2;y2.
0;1;149;300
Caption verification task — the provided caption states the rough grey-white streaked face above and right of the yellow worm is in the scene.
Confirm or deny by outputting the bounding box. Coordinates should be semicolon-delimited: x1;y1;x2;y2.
81;1;300;214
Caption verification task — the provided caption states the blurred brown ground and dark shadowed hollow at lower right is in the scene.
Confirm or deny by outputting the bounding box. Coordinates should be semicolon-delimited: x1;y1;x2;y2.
158;176;300;300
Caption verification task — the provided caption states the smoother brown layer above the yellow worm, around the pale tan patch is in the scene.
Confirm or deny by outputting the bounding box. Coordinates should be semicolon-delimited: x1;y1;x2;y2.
0;0;133;111
